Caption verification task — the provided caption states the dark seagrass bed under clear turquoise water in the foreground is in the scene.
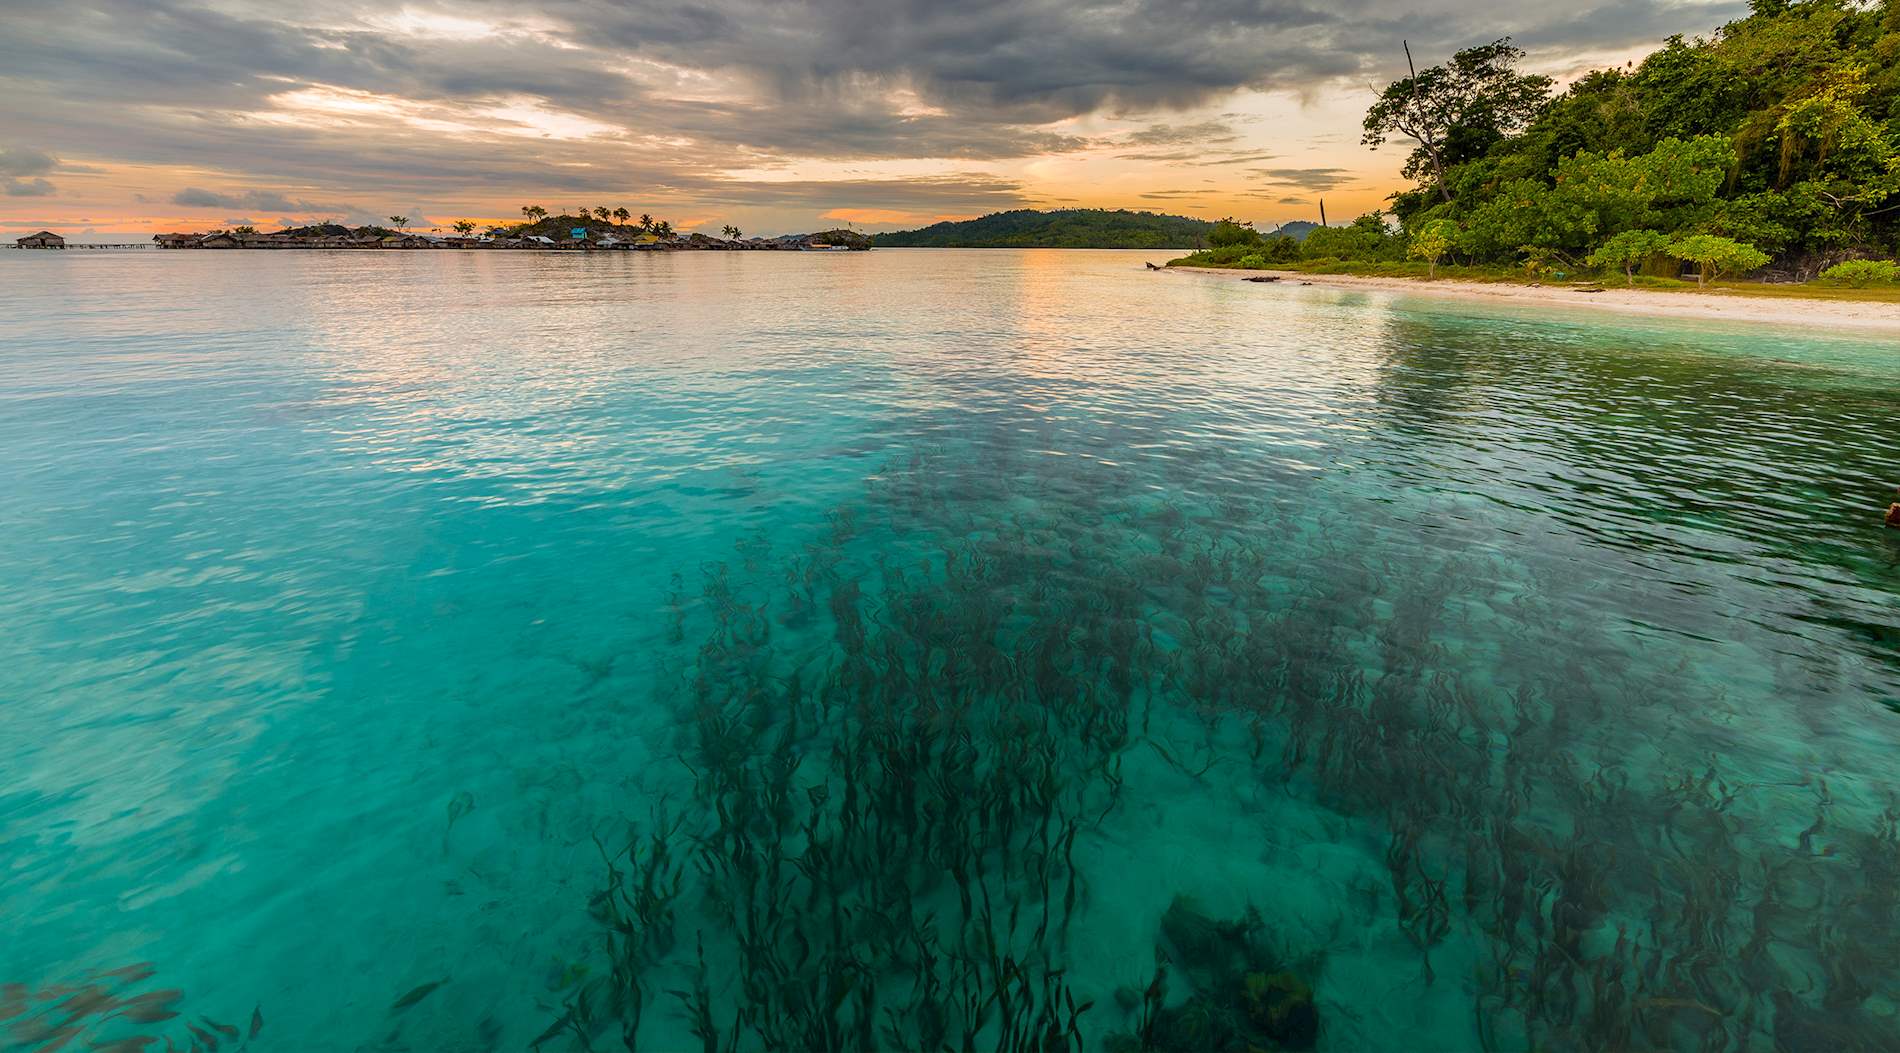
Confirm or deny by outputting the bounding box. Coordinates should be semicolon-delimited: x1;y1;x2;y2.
538;387;1900;1053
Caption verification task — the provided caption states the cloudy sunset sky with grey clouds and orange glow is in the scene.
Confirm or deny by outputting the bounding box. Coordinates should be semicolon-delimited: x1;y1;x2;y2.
0;0;1744;239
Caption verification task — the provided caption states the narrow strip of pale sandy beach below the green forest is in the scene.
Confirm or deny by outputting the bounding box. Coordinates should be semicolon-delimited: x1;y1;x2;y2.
1167;266;1900;333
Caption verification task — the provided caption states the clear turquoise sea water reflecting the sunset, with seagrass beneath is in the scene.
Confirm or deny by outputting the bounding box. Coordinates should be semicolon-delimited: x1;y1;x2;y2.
0;251;1900;1053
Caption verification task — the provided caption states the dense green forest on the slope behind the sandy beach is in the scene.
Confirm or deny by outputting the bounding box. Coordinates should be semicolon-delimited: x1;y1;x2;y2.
1193;0;1900;283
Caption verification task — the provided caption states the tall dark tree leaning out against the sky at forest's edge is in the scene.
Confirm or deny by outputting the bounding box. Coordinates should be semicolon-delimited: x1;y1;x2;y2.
1362;36;1552;201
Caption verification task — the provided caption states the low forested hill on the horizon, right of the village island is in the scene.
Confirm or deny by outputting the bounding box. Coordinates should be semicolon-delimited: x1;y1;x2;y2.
872;209;1214;249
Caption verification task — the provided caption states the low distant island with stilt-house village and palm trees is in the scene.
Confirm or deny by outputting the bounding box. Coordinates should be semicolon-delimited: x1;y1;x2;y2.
140;205;870;253
